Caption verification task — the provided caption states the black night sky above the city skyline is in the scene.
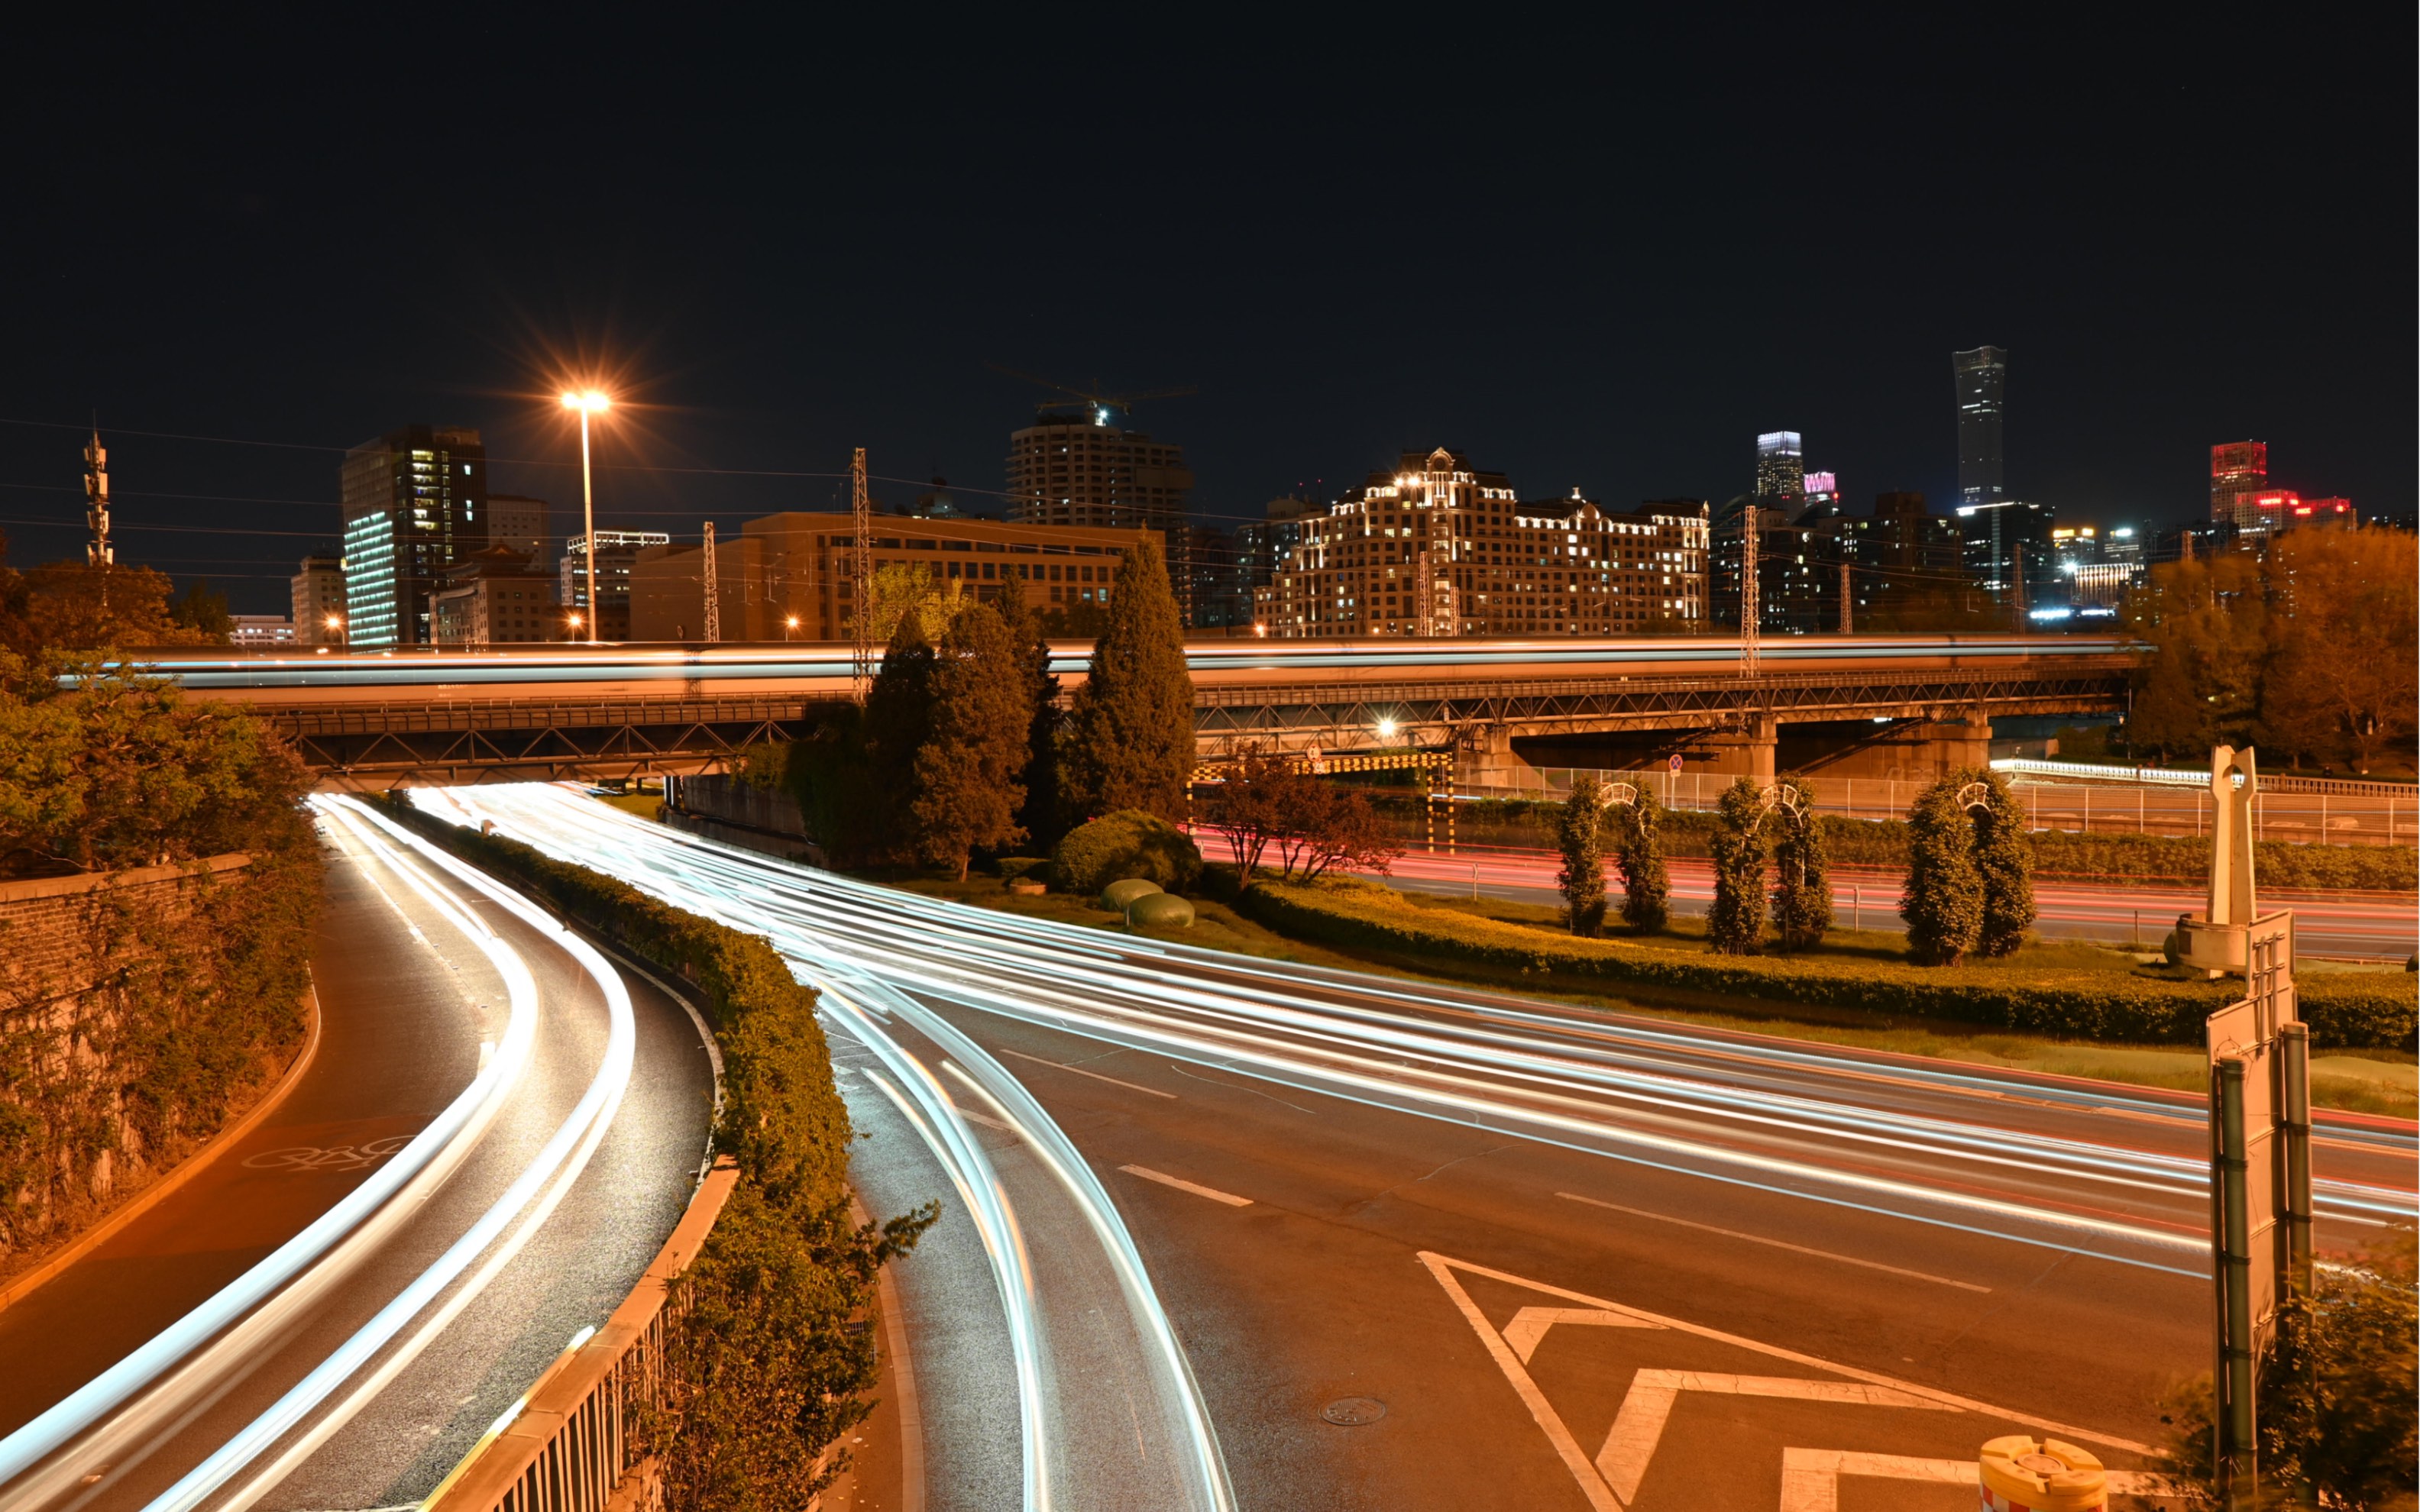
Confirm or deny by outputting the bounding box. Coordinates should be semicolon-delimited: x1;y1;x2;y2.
0;8;2420;612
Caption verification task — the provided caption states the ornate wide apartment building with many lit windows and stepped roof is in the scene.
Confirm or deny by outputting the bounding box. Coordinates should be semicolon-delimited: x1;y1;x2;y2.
1254;447;1709;638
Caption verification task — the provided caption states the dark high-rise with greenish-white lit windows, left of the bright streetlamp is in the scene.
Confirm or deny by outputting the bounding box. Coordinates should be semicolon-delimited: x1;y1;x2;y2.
341;426;487;646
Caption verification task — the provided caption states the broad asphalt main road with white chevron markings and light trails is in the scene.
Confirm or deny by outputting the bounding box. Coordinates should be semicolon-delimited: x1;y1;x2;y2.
462;789;2415;1510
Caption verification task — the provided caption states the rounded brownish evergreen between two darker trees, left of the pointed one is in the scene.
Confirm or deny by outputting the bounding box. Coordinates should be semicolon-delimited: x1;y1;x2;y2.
910;605;1034;880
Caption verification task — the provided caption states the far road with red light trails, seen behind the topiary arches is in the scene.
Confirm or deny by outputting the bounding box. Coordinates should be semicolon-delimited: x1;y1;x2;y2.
1374;837;2420;961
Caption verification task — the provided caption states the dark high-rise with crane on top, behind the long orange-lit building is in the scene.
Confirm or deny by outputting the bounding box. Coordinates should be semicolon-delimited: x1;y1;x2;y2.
1009;404;1193;624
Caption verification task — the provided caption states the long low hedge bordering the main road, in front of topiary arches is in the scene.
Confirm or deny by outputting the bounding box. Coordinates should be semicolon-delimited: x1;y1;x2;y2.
1237;880;2415;1050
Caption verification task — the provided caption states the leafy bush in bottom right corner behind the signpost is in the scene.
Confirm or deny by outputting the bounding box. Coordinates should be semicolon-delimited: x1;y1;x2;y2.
2159;1224;2420;1510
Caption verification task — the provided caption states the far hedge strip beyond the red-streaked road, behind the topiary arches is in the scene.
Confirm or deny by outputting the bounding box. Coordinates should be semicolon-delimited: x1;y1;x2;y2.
1372;793;2420;893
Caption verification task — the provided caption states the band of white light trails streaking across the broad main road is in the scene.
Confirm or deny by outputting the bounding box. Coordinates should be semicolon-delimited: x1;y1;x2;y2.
455;789;2412;1275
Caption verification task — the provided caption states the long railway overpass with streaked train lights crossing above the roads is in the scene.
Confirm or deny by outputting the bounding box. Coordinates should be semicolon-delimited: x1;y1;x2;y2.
138;636;2134;789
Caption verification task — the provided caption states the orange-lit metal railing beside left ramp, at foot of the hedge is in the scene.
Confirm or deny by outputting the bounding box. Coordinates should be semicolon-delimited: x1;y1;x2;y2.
421;1156;740;1512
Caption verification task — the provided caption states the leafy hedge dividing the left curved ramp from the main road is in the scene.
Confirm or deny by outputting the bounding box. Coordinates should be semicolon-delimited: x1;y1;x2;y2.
390;798;937;1507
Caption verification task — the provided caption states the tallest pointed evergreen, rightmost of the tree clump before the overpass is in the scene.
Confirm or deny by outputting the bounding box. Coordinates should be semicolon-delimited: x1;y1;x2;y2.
1060;535;1193;822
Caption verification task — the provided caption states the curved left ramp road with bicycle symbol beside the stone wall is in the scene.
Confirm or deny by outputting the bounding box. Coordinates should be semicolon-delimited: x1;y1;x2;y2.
0;798;711;1510
